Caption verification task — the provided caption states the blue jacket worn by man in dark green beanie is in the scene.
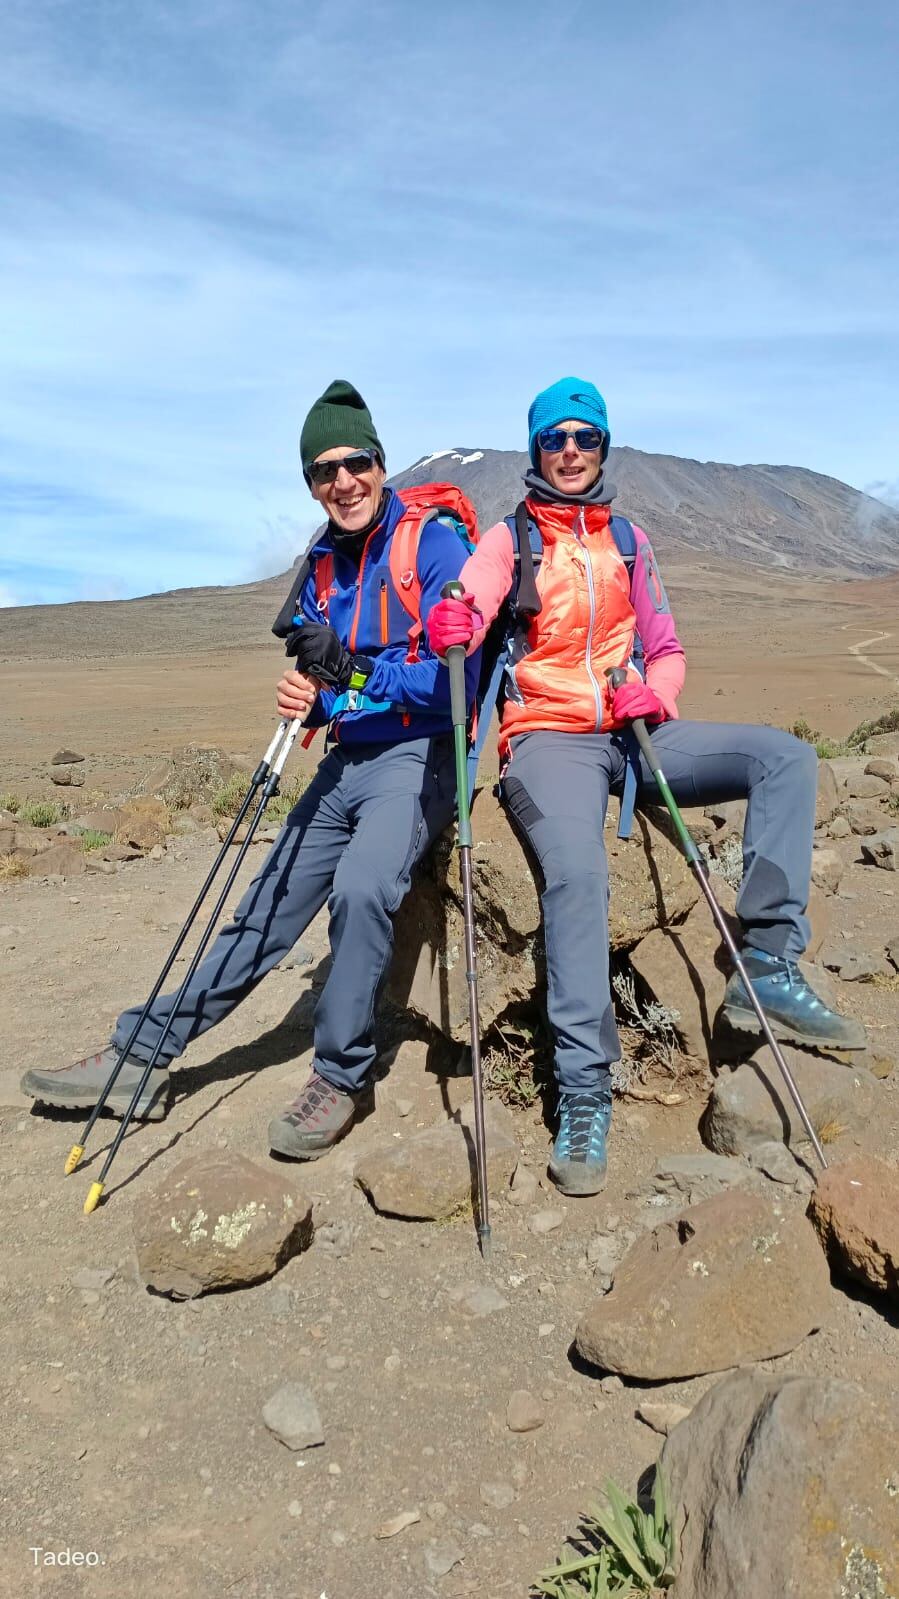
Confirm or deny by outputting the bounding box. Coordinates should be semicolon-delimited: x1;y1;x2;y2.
298;489;480;747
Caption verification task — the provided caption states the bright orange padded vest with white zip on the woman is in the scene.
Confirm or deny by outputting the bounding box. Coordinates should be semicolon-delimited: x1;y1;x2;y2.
499;499;637;761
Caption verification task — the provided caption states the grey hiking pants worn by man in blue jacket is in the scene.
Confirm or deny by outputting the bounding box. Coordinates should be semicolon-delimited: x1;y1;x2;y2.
112;737;456;1092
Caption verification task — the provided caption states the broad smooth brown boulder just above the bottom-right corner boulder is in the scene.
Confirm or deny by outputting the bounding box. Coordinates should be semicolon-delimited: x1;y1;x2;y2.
574;1188;832;1382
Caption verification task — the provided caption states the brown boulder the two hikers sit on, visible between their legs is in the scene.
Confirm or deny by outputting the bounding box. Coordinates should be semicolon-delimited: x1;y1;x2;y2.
390;788;699;1043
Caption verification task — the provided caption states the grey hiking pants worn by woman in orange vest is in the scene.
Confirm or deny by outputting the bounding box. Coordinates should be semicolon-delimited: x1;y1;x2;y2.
502;721;817;1092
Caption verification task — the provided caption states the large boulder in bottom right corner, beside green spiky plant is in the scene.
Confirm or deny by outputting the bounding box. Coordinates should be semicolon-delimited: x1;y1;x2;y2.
657;1372;899;1599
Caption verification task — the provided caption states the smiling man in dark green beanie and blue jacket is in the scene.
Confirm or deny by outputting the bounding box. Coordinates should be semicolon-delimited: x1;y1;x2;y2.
22;381;477;1161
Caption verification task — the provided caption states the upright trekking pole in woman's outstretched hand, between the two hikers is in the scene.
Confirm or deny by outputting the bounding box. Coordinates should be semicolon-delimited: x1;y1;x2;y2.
440;584;493;1260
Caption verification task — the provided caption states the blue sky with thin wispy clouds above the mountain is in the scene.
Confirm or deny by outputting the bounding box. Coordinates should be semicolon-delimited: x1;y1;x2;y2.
0;0;899;604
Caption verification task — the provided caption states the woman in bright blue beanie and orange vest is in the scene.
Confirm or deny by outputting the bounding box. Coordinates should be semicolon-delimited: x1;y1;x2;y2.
427;377;865;1194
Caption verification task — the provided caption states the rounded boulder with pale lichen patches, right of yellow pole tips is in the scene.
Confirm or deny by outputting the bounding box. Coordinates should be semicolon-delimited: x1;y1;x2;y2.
133;1150;312;1298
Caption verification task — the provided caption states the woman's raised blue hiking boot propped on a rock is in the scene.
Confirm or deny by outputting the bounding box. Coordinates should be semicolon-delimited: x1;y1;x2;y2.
725;948;867;1049
